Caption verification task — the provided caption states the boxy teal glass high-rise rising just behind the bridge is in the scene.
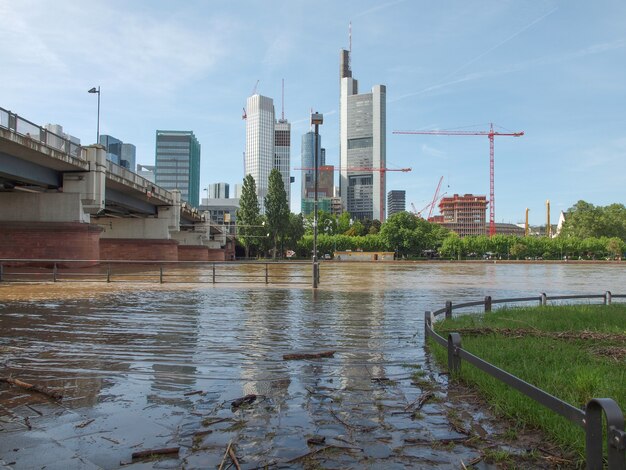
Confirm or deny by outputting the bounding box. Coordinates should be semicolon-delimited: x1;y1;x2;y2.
155;130;200;207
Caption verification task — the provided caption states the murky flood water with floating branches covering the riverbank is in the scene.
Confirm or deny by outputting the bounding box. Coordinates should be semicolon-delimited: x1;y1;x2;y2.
0;263;626;469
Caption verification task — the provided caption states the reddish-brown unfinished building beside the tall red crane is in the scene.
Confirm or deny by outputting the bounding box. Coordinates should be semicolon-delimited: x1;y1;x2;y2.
428;194;487;237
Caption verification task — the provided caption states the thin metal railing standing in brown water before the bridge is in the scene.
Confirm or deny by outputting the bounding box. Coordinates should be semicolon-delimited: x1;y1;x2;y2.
0;259;313;285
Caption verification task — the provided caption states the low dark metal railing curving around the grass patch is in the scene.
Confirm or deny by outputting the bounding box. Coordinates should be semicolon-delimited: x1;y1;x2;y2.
424;291;626;470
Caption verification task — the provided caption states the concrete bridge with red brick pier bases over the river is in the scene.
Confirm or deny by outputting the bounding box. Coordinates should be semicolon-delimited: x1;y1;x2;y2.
0;107;234;261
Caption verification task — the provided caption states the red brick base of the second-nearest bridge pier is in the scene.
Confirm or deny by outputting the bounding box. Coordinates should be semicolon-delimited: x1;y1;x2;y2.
100;238;178;261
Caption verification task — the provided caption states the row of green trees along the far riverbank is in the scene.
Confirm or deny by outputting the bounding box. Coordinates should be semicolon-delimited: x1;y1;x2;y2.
237;175;626;259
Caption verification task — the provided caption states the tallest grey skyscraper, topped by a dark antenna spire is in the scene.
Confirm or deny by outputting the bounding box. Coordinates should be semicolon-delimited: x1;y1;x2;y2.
339;50;387;222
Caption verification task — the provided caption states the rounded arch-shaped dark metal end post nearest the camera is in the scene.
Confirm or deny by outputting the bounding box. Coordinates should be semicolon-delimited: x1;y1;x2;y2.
585;398;626;470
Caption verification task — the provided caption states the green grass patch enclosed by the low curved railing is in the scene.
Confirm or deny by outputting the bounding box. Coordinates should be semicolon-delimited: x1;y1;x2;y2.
429;304;626;458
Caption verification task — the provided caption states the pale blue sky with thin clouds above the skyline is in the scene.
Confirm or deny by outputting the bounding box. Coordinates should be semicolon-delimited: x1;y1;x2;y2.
0;0;626;225
